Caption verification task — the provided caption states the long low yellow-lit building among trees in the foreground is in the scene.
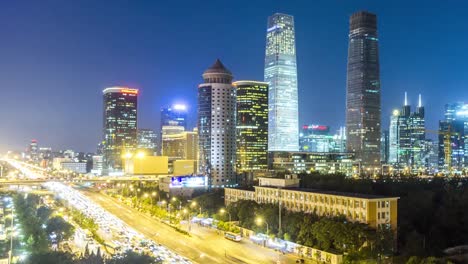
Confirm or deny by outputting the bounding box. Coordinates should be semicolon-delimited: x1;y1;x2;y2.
224;178;399;231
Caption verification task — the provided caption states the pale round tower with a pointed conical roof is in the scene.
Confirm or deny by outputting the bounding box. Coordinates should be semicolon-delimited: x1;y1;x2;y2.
198;60;236;188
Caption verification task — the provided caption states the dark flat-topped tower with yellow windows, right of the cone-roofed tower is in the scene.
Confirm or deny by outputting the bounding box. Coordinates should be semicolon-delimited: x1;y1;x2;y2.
233;81;268;172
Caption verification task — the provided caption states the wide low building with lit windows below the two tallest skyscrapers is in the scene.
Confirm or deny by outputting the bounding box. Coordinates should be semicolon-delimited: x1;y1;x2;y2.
268;151;360;176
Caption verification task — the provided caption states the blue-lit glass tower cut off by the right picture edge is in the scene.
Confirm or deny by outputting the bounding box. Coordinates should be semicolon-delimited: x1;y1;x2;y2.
438;102;468;172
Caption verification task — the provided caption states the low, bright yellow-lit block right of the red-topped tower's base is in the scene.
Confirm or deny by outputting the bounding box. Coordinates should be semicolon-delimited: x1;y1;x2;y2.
124;154;169;175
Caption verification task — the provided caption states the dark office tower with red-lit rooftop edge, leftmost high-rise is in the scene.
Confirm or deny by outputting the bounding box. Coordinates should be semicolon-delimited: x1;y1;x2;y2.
103;87;138;172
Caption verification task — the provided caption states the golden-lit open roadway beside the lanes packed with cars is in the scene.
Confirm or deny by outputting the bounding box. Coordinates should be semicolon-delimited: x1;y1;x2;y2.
81;190;297;263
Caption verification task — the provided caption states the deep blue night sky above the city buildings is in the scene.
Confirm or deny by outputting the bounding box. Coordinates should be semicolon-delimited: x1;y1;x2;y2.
0;0;468;152
